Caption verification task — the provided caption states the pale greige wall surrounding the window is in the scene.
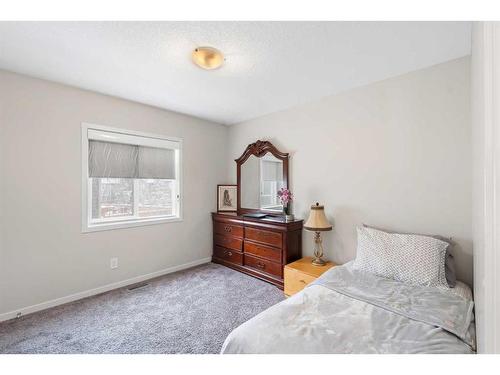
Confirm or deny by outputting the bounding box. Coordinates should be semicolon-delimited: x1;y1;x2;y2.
0;71;227;318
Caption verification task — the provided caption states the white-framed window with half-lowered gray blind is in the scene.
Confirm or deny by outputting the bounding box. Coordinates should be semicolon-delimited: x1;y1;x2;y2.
82;124;182;232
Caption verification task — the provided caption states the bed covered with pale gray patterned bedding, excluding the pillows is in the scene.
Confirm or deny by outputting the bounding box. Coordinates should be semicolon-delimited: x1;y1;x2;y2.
221;263;475;354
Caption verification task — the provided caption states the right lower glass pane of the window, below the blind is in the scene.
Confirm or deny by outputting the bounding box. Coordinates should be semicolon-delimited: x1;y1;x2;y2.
136;179;175;217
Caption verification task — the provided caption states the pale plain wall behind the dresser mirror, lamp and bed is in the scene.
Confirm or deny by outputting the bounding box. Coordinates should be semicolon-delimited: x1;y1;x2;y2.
228;57;472;283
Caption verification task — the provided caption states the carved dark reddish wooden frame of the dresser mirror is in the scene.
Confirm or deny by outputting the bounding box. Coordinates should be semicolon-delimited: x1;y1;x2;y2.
234;140;289;216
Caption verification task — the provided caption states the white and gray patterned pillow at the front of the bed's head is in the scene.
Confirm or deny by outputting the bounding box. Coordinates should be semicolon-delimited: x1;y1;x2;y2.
353;227;449;289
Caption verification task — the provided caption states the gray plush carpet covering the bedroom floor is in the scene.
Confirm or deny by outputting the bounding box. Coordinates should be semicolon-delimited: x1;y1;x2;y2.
0;264;284;353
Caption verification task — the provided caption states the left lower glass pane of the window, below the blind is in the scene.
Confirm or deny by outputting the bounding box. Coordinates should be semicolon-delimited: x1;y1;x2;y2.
91;178;134;219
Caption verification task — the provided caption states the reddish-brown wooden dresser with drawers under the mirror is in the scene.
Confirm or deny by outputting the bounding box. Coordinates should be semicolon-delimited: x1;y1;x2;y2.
212;213;303;289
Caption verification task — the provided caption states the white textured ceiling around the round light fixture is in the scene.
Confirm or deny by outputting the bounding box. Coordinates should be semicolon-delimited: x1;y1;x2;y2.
0;22;471;124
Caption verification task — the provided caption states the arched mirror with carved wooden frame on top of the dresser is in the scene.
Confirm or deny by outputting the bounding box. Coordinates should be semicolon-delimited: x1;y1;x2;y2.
235;141;288;215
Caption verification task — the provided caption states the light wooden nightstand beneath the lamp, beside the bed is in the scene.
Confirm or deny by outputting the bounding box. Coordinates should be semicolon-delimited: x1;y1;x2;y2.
285;257;336;296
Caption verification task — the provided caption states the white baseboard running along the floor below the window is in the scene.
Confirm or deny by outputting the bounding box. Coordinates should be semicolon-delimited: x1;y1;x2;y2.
0;258;211;322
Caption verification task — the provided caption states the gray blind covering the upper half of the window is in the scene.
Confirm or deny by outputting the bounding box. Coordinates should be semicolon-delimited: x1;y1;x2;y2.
88;131;176;179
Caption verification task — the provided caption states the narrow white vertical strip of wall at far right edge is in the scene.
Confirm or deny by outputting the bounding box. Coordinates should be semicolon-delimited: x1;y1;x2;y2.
471;22;500;353
